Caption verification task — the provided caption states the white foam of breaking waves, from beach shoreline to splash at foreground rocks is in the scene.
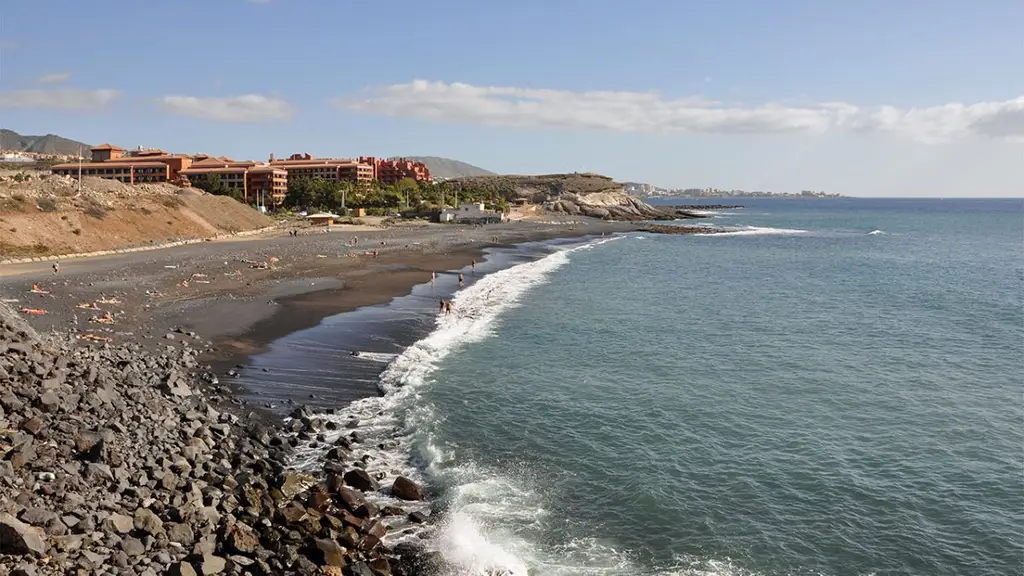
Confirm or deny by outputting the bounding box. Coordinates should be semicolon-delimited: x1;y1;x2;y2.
284;236;627;576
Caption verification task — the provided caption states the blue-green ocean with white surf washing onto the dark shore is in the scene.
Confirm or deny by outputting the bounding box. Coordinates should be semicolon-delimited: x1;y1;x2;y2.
244;199;1024;576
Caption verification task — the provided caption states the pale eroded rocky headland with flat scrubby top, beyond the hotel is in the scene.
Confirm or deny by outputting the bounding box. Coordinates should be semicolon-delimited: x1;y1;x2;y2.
451;173;703;220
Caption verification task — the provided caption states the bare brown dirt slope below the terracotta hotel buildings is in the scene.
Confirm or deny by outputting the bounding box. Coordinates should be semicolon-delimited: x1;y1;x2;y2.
0;170;272;257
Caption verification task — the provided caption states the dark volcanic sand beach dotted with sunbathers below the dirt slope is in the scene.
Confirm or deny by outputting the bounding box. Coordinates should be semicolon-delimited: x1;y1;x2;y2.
0;218;636;377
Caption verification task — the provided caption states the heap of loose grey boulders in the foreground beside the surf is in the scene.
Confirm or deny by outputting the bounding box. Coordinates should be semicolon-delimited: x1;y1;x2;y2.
0;304;441;576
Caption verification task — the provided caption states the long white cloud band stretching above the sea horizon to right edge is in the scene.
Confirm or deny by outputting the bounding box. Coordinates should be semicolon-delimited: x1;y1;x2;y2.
334;80;1024;142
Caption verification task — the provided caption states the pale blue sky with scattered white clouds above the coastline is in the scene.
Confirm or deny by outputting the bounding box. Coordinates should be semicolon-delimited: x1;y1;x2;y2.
0;0;1024;197
